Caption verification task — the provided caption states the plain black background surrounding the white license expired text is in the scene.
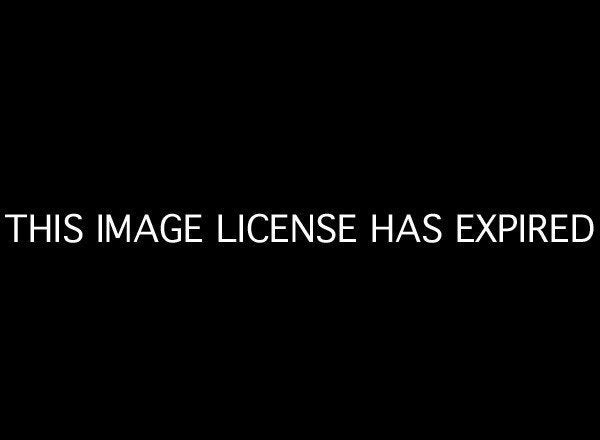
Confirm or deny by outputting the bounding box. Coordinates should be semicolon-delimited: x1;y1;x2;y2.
1;5;598;433
